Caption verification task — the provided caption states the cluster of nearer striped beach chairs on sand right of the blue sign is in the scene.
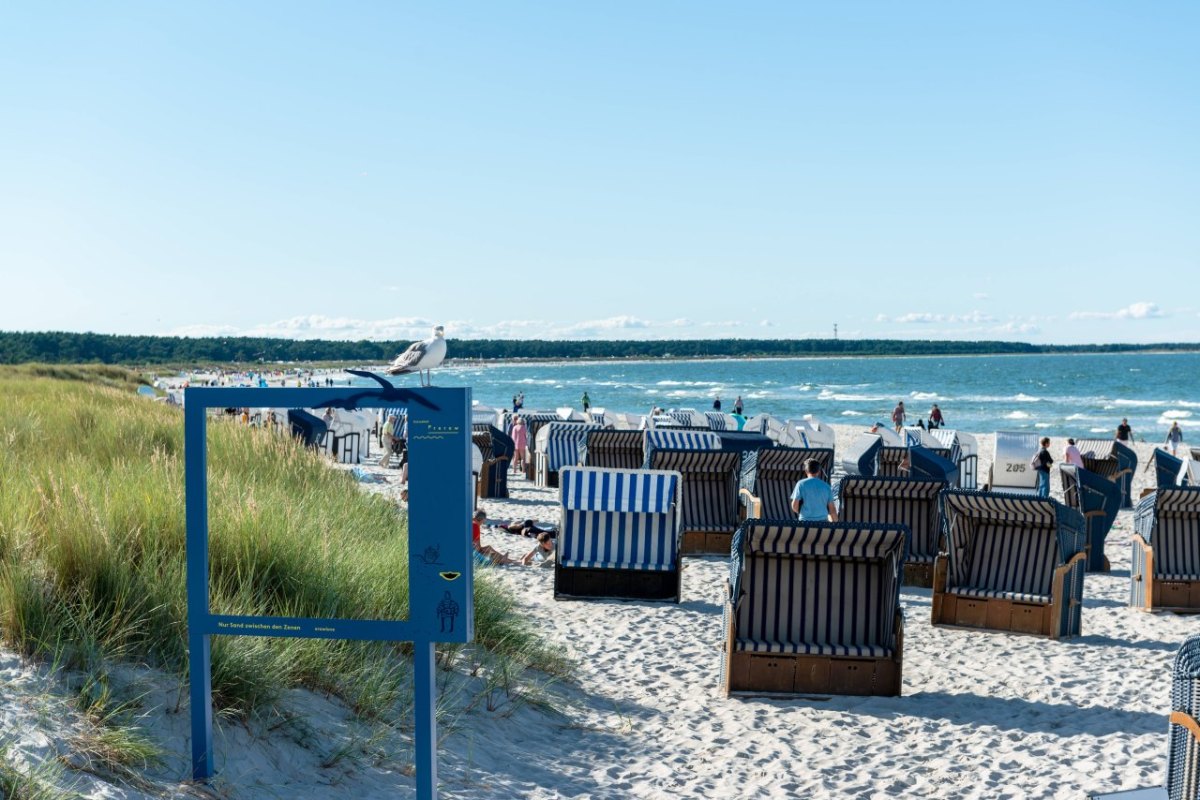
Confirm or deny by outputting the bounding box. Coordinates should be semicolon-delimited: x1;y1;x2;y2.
535;423;1200;694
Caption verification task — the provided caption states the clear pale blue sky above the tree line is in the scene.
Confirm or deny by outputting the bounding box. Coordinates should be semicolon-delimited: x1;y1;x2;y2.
0;1;1200;343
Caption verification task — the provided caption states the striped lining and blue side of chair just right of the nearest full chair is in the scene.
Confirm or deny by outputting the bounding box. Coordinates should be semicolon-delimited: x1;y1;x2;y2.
941;489;1085;618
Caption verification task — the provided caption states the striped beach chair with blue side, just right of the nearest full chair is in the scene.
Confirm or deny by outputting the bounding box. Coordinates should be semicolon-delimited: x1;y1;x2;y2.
932;489;1087;639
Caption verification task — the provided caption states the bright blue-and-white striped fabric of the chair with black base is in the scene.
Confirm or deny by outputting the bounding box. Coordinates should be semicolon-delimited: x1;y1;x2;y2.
558;467;682;571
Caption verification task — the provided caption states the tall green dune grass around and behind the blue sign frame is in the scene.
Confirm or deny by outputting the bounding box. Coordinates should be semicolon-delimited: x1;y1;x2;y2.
0;366;565;718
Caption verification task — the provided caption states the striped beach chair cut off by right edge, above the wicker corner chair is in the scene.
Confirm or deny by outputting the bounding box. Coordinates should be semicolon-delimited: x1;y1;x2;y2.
1129;486;1200;610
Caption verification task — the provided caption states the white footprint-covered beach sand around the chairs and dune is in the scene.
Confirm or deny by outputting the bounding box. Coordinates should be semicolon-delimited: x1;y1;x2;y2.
0;426;1180;800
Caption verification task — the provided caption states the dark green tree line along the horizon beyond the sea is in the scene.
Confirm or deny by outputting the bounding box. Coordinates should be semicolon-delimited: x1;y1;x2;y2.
0;331;1200;366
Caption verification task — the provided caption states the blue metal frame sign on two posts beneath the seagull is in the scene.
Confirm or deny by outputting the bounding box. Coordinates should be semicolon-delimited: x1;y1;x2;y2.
184;378;475;800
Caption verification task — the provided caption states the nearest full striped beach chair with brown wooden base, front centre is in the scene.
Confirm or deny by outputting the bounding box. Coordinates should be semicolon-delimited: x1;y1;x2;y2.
721;519;905;696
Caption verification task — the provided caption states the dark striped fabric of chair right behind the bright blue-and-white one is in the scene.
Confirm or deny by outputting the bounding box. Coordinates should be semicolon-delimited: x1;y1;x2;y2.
646;450;742;533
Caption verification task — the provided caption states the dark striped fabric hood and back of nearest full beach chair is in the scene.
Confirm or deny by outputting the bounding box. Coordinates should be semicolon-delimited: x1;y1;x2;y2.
730;519;904;657
